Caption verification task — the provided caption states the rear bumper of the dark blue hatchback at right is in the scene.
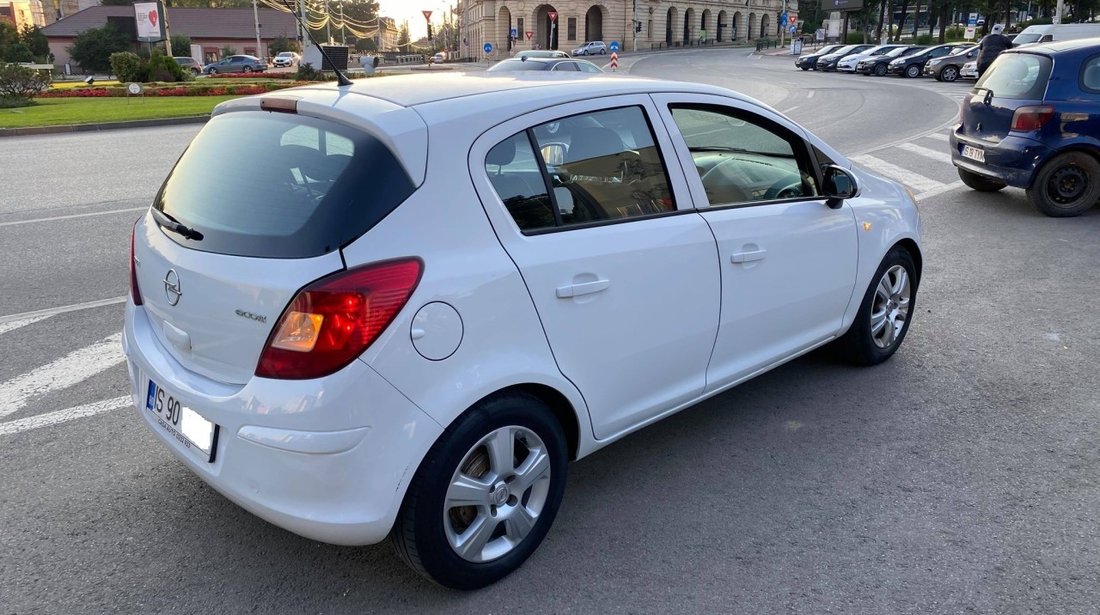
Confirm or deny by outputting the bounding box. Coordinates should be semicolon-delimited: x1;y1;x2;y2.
949;128;1052;188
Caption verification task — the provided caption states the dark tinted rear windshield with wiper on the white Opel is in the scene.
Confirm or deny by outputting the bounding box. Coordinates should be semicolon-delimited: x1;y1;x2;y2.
153;111;415;259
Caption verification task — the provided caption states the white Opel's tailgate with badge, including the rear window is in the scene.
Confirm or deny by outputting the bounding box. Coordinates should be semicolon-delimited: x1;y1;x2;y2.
134;111;414;384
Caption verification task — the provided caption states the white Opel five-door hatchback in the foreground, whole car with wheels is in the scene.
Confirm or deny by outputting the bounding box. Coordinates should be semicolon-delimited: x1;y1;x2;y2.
123;73;922;589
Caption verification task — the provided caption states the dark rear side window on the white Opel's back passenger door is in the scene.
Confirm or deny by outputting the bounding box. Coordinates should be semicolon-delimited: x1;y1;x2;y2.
485;107;675;231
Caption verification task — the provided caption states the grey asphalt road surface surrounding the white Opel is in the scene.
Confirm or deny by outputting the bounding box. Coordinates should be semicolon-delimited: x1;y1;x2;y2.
0;51;1100;614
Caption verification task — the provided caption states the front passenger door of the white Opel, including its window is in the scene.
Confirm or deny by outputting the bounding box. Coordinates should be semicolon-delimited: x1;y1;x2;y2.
655;96;857;391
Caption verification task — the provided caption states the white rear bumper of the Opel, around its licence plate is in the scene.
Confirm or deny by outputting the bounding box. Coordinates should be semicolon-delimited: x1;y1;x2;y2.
122;304;442;545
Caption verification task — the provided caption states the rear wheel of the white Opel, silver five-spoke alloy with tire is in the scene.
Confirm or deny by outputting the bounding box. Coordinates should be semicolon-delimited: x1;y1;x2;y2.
391;393;569;590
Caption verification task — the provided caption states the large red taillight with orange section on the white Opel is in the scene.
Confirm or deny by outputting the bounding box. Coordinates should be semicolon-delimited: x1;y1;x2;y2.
256;259;422;380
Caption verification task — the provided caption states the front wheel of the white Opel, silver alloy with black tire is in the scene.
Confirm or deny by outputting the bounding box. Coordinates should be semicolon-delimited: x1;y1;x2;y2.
839;245;919;365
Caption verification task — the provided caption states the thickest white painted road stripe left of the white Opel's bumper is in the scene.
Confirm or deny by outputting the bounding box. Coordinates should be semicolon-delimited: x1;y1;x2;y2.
0;333;125;418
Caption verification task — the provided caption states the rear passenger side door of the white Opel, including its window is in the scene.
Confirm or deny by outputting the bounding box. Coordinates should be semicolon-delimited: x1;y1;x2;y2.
470;96;719;438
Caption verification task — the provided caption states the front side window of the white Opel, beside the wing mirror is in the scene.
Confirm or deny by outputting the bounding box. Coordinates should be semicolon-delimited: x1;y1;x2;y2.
671;106;820;206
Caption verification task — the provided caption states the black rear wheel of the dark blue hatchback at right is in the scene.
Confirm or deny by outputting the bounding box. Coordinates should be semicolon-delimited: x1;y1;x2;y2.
1027;152;1100;218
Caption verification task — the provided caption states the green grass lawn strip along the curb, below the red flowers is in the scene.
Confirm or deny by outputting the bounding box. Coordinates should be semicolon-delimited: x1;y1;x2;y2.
0;96;239;129
